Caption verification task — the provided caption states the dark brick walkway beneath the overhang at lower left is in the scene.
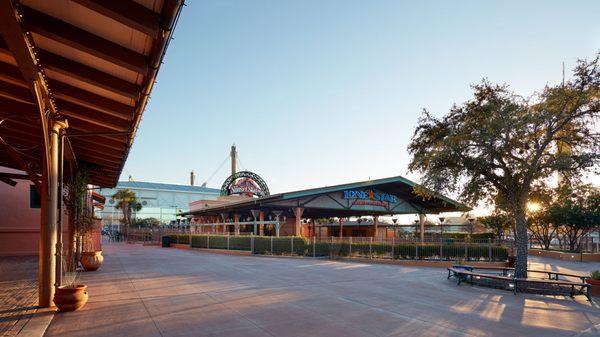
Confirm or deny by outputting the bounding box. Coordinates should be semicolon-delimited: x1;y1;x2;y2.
0;256;38;337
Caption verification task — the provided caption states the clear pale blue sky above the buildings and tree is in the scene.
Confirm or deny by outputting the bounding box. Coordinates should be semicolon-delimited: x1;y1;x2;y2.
121;0;600;196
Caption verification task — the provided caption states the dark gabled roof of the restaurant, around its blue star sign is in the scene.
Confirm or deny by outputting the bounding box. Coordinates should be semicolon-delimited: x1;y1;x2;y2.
182;176;470;218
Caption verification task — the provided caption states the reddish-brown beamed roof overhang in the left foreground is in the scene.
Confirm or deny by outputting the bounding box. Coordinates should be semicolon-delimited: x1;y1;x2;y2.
0;0;183;187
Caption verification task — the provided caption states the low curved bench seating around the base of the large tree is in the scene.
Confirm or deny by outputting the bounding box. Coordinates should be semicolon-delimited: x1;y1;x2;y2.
448;267;592;301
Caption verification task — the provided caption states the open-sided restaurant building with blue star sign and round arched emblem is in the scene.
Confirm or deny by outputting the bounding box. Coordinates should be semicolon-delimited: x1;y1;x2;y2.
182;172;470;240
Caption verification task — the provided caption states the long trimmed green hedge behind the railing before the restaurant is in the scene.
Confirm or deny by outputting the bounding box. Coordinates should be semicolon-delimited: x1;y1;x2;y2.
164;235;508;261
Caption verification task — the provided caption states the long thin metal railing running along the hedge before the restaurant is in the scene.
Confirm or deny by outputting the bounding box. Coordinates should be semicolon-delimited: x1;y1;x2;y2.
163;233;508;261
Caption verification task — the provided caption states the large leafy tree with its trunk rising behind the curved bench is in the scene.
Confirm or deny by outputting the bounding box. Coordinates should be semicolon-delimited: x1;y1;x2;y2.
408;53;600;277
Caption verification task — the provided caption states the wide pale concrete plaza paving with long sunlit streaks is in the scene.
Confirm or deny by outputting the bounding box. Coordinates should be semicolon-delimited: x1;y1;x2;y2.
46;244;600;337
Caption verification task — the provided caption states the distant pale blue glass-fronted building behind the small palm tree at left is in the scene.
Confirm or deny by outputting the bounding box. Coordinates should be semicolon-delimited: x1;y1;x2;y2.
96;181;221;229
